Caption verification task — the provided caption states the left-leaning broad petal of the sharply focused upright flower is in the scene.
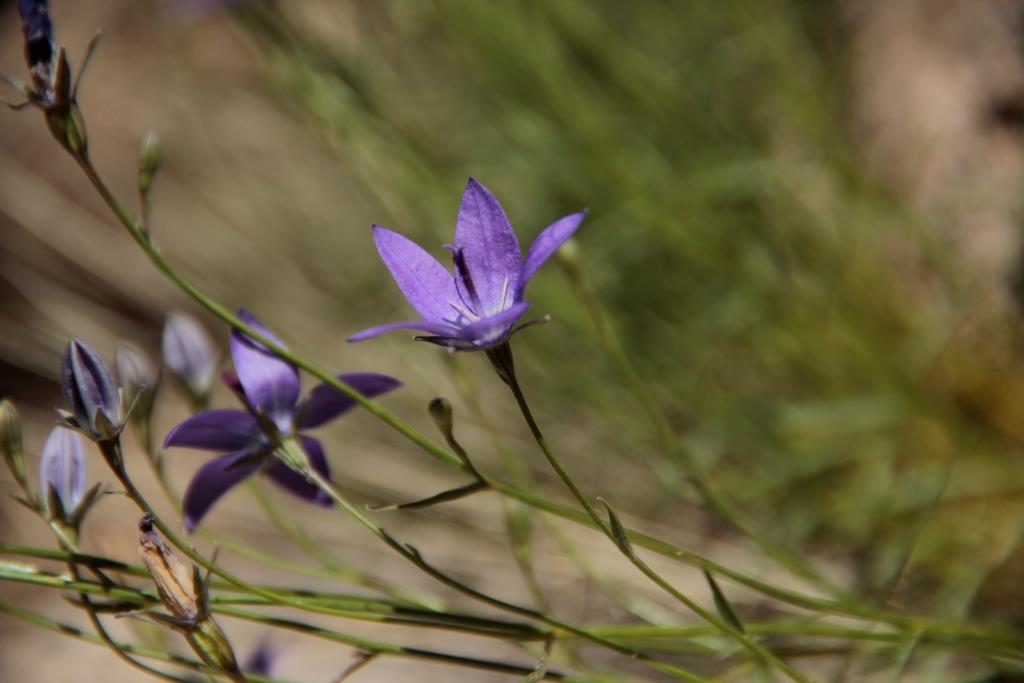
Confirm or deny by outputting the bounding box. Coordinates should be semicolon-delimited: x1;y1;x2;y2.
374;225;459;322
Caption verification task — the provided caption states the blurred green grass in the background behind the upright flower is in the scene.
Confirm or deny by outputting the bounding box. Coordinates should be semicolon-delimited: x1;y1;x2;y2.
224;0;1022;610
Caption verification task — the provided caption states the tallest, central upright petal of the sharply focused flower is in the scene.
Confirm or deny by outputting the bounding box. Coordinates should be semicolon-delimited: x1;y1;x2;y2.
455;178;522;315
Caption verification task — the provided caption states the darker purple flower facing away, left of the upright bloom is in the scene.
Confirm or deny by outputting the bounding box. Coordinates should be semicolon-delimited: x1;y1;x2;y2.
164;309;400;531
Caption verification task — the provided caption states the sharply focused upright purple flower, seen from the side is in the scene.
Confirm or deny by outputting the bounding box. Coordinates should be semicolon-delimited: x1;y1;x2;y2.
348;178;587;350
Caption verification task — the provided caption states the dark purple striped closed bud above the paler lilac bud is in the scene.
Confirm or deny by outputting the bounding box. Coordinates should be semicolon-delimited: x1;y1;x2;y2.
60;339;122;438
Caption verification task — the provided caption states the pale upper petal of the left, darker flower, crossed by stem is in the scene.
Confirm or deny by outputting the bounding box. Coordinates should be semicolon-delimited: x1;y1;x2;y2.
231;308;301;433
